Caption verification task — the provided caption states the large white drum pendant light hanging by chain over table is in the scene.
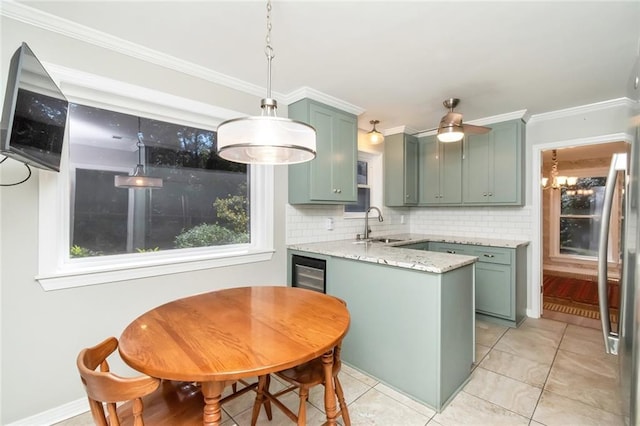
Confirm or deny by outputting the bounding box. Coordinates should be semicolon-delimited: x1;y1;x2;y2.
217;0;316;164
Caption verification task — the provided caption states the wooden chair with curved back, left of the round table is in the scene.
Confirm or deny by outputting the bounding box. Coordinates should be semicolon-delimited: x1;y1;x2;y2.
76;337;262;426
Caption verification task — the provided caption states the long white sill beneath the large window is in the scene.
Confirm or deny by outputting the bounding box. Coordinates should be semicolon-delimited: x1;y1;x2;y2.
35;249;274;291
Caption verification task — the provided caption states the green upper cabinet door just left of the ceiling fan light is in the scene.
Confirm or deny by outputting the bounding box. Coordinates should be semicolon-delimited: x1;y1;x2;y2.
418;136;440;205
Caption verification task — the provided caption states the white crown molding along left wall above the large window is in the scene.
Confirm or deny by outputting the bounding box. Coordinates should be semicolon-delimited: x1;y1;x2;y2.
0;0;285;98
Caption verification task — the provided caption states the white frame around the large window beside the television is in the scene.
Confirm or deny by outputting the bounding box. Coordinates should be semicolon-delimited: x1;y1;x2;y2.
36;64;275;290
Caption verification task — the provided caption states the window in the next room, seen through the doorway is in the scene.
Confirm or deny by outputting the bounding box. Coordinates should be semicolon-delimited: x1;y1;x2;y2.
551;172;621;261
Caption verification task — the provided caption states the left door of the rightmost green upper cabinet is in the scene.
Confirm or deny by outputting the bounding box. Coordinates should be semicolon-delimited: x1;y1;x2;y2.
463;133;491;203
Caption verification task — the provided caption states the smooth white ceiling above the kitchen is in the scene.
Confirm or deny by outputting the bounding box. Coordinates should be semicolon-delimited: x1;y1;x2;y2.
17;0;640;130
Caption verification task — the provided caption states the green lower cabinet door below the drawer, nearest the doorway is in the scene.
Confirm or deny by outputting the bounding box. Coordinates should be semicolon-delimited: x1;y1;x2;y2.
476;262;513;319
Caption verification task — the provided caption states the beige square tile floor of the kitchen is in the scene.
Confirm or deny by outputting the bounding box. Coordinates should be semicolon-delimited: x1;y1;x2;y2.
59;318;624;426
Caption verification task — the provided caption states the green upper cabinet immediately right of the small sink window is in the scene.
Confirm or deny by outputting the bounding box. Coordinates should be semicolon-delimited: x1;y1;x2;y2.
383;133;418;207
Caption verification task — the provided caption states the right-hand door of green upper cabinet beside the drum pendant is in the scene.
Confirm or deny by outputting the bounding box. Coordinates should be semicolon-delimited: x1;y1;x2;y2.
330;113;358;202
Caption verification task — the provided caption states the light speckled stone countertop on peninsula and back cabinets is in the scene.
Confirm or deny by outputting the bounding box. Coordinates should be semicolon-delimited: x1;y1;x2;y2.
288;234;529;274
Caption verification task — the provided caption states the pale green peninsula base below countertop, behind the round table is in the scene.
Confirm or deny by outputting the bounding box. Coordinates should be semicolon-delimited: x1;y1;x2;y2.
327;257;474;411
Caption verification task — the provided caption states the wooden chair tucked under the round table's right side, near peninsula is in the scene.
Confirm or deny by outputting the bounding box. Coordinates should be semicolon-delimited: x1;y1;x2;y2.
251;299;351;426
